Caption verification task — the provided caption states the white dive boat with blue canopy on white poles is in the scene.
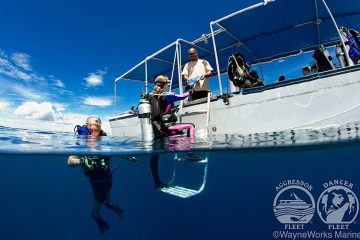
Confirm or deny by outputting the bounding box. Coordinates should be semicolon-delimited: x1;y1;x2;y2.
110;0;360;137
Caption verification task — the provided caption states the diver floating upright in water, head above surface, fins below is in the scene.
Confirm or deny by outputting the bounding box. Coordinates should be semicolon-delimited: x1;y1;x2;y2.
67;116;123;233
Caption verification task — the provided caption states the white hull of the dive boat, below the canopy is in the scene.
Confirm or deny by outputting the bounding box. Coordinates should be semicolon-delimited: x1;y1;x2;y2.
110;66;360;137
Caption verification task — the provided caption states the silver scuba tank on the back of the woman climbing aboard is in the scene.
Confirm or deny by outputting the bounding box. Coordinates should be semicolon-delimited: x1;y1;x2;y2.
138;99;154;141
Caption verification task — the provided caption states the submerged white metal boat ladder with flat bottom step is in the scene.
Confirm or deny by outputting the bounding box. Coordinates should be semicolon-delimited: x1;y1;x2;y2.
159;152;208;198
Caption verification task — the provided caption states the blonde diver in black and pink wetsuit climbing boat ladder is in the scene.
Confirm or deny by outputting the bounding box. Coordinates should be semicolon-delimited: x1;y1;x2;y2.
148;75;193;138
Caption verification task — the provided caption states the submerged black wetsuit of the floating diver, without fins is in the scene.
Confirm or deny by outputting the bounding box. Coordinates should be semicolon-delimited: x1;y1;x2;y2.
81;156;112;203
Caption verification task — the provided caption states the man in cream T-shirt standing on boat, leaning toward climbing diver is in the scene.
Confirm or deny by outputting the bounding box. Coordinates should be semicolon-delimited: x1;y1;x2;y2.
181;48;213;101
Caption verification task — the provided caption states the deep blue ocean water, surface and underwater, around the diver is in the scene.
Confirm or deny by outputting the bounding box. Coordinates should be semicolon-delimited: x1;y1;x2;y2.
0;123;360;240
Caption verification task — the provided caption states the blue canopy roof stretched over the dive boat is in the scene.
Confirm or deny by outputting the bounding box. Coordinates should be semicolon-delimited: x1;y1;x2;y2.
115;0;360;88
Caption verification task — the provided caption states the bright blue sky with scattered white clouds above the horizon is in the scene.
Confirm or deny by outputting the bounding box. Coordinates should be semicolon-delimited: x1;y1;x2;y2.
0;0;255;131
